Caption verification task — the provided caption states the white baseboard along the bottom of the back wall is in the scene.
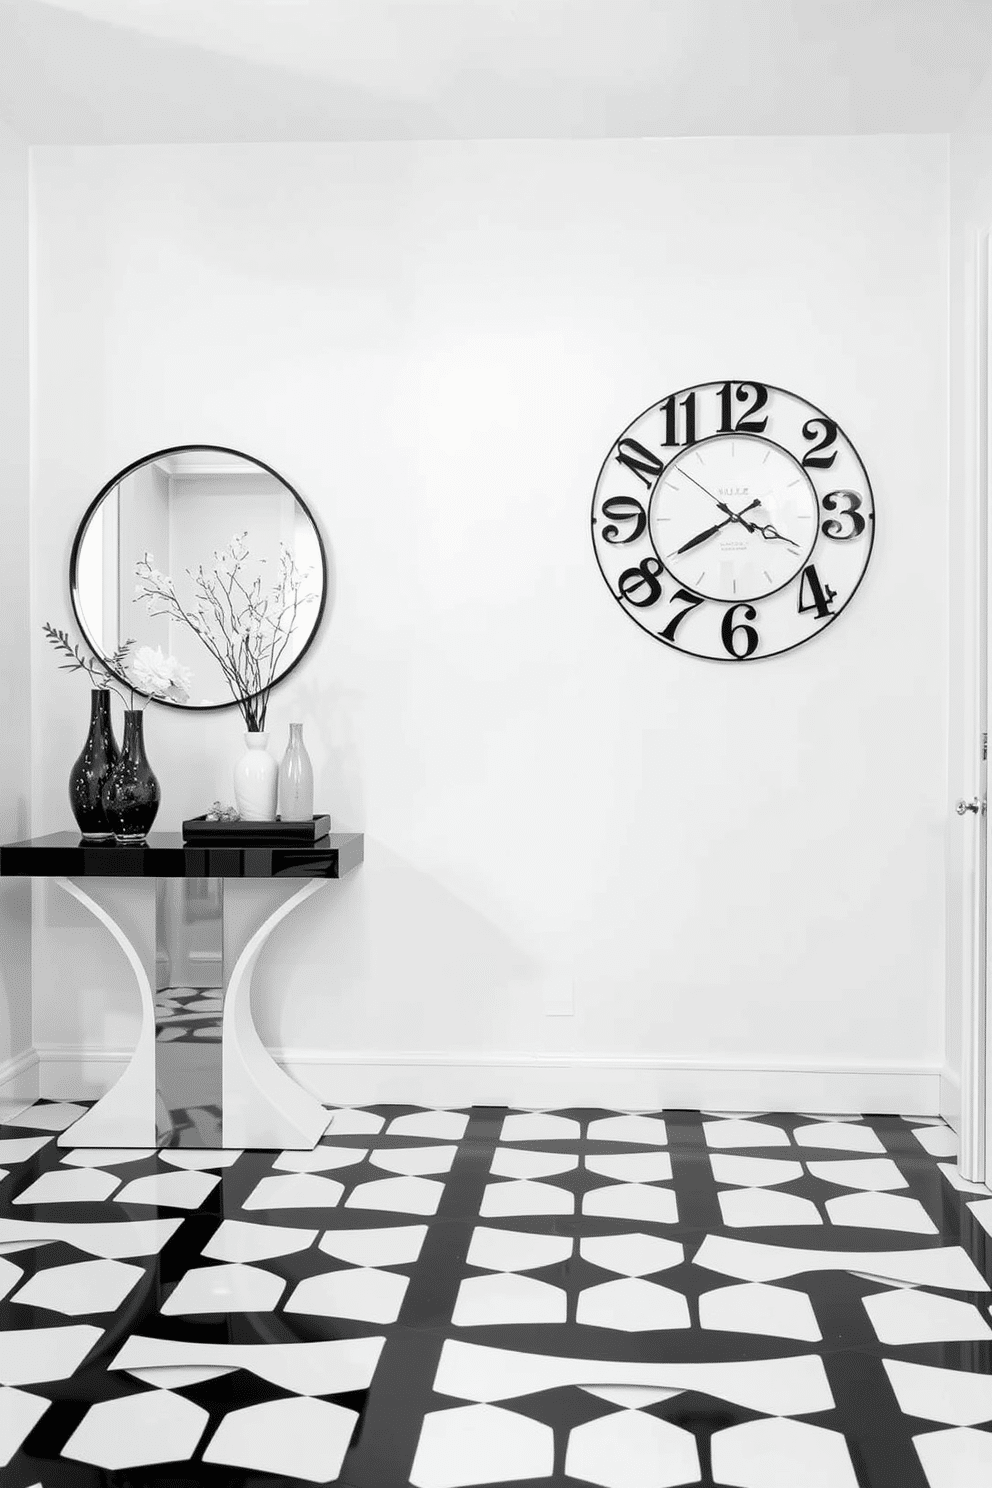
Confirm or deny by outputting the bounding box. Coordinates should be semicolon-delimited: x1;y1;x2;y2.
37;1045;941;1116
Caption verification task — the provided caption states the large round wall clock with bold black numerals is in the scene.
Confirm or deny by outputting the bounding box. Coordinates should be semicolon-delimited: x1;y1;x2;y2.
592;382;875;661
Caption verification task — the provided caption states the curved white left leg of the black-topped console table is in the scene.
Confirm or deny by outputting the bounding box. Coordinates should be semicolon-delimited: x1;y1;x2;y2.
55;878;158;1147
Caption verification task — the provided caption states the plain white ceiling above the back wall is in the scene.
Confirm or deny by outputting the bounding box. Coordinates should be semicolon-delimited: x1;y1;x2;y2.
0;0;992;144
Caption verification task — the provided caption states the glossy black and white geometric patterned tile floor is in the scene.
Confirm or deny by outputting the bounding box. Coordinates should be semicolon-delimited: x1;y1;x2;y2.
0;1101;992;1488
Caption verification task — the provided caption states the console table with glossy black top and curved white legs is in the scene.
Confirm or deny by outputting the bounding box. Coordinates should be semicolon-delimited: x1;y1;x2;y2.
0;832;364;1149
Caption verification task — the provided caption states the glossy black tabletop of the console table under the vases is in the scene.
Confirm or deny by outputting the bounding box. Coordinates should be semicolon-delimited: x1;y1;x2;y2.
0;832;364;878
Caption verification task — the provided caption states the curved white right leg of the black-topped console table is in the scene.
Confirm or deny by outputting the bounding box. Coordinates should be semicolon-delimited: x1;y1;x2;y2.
222;878;330;1149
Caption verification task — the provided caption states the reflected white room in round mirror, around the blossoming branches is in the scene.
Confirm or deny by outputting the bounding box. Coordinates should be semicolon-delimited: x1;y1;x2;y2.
70;445;327;708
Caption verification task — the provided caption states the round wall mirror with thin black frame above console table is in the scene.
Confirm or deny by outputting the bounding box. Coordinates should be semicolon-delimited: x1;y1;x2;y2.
68;445;327;708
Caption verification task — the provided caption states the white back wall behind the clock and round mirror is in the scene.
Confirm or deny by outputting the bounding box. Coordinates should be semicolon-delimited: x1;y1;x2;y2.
33;137;949;1109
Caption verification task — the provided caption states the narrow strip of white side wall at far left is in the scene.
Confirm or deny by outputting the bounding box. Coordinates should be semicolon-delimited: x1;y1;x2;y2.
0;124;34;1109
